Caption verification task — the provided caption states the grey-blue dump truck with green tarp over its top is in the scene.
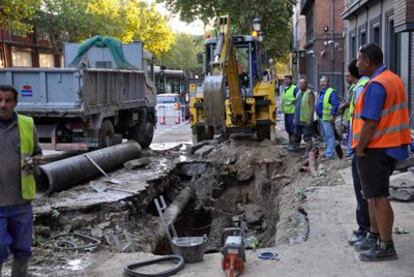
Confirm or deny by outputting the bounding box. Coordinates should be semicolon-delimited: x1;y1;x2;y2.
0;36;156;151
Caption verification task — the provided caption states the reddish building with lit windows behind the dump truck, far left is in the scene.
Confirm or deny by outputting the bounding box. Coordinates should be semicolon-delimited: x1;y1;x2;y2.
0;27;61;68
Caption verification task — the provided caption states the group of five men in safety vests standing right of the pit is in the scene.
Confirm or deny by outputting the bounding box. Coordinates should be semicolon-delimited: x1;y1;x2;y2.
282;43;412;261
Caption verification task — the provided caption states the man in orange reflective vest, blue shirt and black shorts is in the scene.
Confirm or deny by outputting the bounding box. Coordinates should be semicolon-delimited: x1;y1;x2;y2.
352;43;411;261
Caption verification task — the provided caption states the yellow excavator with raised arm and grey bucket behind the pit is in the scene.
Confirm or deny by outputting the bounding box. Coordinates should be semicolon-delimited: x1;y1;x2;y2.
189;16;276;142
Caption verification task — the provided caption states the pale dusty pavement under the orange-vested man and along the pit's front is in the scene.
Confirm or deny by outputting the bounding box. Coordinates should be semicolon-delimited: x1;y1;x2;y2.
85;165;414;277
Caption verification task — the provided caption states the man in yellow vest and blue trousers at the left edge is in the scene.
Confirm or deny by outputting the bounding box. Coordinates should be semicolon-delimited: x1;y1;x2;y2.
0;85;42;277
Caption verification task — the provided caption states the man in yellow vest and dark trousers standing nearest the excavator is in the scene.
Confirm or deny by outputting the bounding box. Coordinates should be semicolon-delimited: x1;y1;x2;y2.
282;75;299;151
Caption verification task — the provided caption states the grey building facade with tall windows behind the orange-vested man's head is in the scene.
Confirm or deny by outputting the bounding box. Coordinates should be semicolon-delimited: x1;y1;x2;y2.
342;0;414;121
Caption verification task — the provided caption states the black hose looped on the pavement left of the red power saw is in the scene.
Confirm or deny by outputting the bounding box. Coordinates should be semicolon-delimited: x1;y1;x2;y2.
124;255;185;277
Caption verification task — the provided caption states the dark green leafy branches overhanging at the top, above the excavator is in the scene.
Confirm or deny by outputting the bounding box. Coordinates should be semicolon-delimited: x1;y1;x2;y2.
158;0;295;58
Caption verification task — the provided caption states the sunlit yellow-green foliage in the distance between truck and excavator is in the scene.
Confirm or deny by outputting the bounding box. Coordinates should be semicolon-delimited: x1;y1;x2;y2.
158;34;204;74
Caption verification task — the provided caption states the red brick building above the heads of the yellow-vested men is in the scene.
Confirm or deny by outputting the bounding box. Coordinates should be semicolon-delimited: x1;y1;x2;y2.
292;0;344;95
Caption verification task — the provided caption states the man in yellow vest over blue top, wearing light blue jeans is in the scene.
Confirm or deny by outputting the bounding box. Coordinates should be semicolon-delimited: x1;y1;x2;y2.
316;76;339;159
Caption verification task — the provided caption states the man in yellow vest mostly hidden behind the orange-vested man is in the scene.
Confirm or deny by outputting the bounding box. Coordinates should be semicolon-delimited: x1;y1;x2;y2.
343;59;370;246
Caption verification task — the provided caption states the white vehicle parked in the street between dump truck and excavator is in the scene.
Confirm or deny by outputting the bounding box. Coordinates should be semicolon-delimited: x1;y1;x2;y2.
156;93;190;123
